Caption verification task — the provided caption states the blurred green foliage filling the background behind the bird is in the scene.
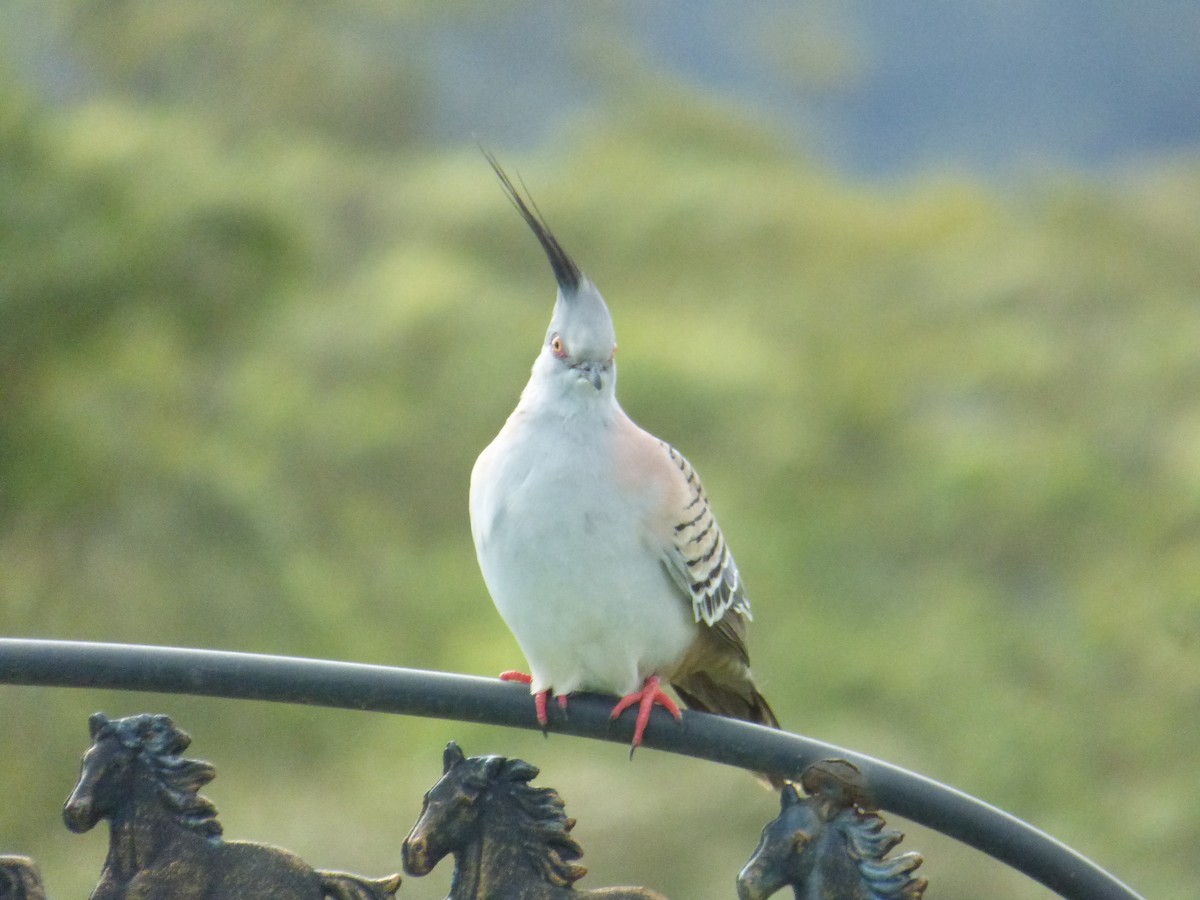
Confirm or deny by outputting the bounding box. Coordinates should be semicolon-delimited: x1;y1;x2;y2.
0;2;1200;898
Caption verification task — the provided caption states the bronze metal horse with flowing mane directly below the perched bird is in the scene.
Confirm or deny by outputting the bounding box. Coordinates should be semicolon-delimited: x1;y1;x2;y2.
403;740;665;900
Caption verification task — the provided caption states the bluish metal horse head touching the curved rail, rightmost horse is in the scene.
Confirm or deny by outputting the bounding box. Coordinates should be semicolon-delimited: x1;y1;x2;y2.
738;760;926;900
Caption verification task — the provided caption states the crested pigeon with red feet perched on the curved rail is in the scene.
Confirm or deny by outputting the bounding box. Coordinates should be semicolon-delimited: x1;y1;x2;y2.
470;154;779;748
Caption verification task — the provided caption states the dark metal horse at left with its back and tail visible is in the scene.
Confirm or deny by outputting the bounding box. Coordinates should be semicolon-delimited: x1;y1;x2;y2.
62;713;400;900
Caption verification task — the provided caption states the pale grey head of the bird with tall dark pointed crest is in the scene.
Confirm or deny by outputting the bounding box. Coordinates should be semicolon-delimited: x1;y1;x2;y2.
487;155;617;396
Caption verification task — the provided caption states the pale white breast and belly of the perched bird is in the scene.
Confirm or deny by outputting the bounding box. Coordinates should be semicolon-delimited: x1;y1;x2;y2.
470;408;697;694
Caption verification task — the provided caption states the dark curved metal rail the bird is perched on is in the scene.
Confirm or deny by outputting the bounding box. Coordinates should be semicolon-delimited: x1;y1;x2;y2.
0;638;1140;900
